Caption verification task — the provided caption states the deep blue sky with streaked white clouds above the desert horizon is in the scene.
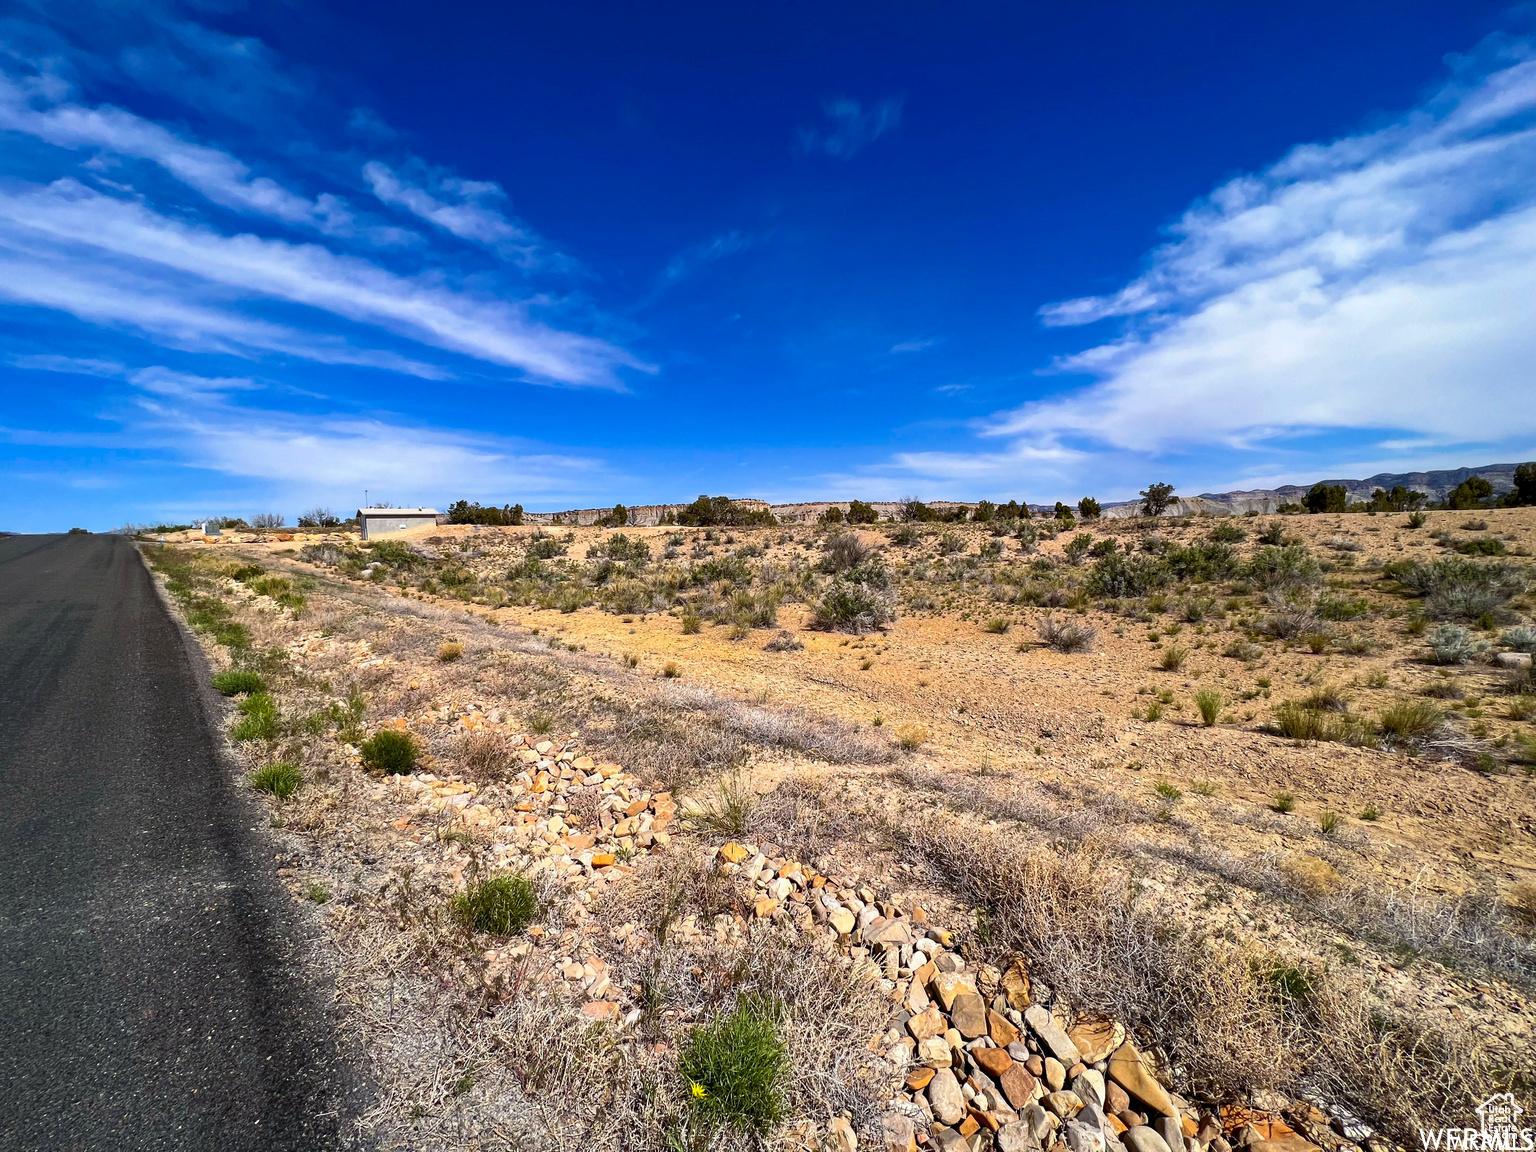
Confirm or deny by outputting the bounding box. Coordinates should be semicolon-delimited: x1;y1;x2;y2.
0;0;1536;530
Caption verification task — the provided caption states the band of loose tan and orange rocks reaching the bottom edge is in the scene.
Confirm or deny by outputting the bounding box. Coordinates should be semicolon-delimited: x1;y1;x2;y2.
714;842;1353;1152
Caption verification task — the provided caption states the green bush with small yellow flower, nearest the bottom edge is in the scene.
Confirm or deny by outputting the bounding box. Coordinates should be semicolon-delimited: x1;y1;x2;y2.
679;995;790;1135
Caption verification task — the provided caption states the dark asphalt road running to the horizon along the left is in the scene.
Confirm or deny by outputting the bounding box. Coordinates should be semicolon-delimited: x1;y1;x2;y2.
0;536;364;1152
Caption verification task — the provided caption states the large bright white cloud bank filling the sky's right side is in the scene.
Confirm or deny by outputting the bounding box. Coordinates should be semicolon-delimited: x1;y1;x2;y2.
985;45;1536;458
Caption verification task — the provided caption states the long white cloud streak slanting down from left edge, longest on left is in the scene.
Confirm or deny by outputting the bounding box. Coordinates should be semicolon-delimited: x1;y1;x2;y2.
0;180;648;389
